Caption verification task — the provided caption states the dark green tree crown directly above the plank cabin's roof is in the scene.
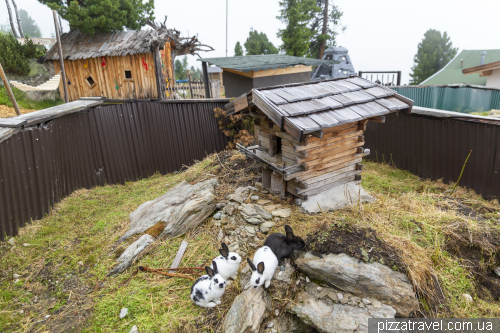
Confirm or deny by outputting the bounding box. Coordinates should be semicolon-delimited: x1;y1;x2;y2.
38;0;154;35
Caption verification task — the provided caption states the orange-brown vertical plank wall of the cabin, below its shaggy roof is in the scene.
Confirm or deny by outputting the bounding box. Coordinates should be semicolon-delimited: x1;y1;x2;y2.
54;53;158;101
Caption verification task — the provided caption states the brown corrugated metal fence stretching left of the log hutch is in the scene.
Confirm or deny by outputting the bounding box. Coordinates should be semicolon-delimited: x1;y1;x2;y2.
0;101;227;240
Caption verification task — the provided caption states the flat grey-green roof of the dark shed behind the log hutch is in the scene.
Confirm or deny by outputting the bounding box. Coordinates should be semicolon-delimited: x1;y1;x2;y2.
198;54;338;72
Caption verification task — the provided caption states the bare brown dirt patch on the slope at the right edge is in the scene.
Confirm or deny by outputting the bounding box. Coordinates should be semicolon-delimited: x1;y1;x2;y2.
444;223;500;301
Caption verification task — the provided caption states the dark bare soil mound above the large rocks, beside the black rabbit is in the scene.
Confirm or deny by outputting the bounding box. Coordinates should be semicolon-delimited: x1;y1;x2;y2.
306;223;406;273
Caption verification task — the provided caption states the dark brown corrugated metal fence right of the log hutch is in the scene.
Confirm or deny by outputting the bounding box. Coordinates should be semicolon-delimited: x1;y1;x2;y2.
365;114;500;199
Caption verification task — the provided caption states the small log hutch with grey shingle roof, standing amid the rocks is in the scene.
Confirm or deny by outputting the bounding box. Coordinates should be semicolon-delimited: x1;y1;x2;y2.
225;76;413;200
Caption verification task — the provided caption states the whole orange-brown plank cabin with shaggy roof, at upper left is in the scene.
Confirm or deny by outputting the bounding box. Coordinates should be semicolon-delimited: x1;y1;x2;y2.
44;30;175;101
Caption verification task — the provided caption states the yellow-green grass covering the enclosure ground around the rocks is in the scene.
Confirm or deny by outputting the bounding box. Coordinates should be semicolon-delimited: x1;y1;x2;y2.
0;156;500;332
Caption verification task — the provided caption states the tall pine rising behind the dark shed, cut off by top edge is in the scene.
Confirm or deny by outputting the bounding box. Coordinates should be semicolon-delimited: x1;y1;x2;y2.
277;0;321;57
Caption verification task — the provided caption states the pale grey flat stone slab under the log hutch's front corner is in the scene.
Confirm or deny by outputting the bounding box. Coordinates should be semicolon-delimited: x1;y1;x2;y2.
300;184;374;213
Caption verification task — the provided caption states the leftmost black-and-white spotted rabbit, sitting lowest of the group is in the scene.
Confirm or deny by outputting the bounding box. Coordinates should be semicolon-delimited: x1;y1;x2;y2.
191;261;226;308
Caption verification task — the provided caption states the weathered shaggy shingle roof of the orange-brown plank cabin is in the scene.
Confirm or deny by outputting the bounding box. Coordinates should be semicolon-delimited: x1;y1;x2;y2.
45;30;151;60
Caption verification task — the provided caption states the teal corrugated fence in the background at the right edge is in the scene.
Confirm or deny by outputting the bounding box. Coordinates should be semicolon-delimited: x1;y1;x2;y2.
391;86;500;113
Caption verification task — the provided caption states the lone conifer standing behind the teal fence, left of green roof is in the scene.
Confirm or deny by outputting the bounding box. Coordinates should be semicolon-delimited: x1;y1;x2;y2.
410;29;458;85
